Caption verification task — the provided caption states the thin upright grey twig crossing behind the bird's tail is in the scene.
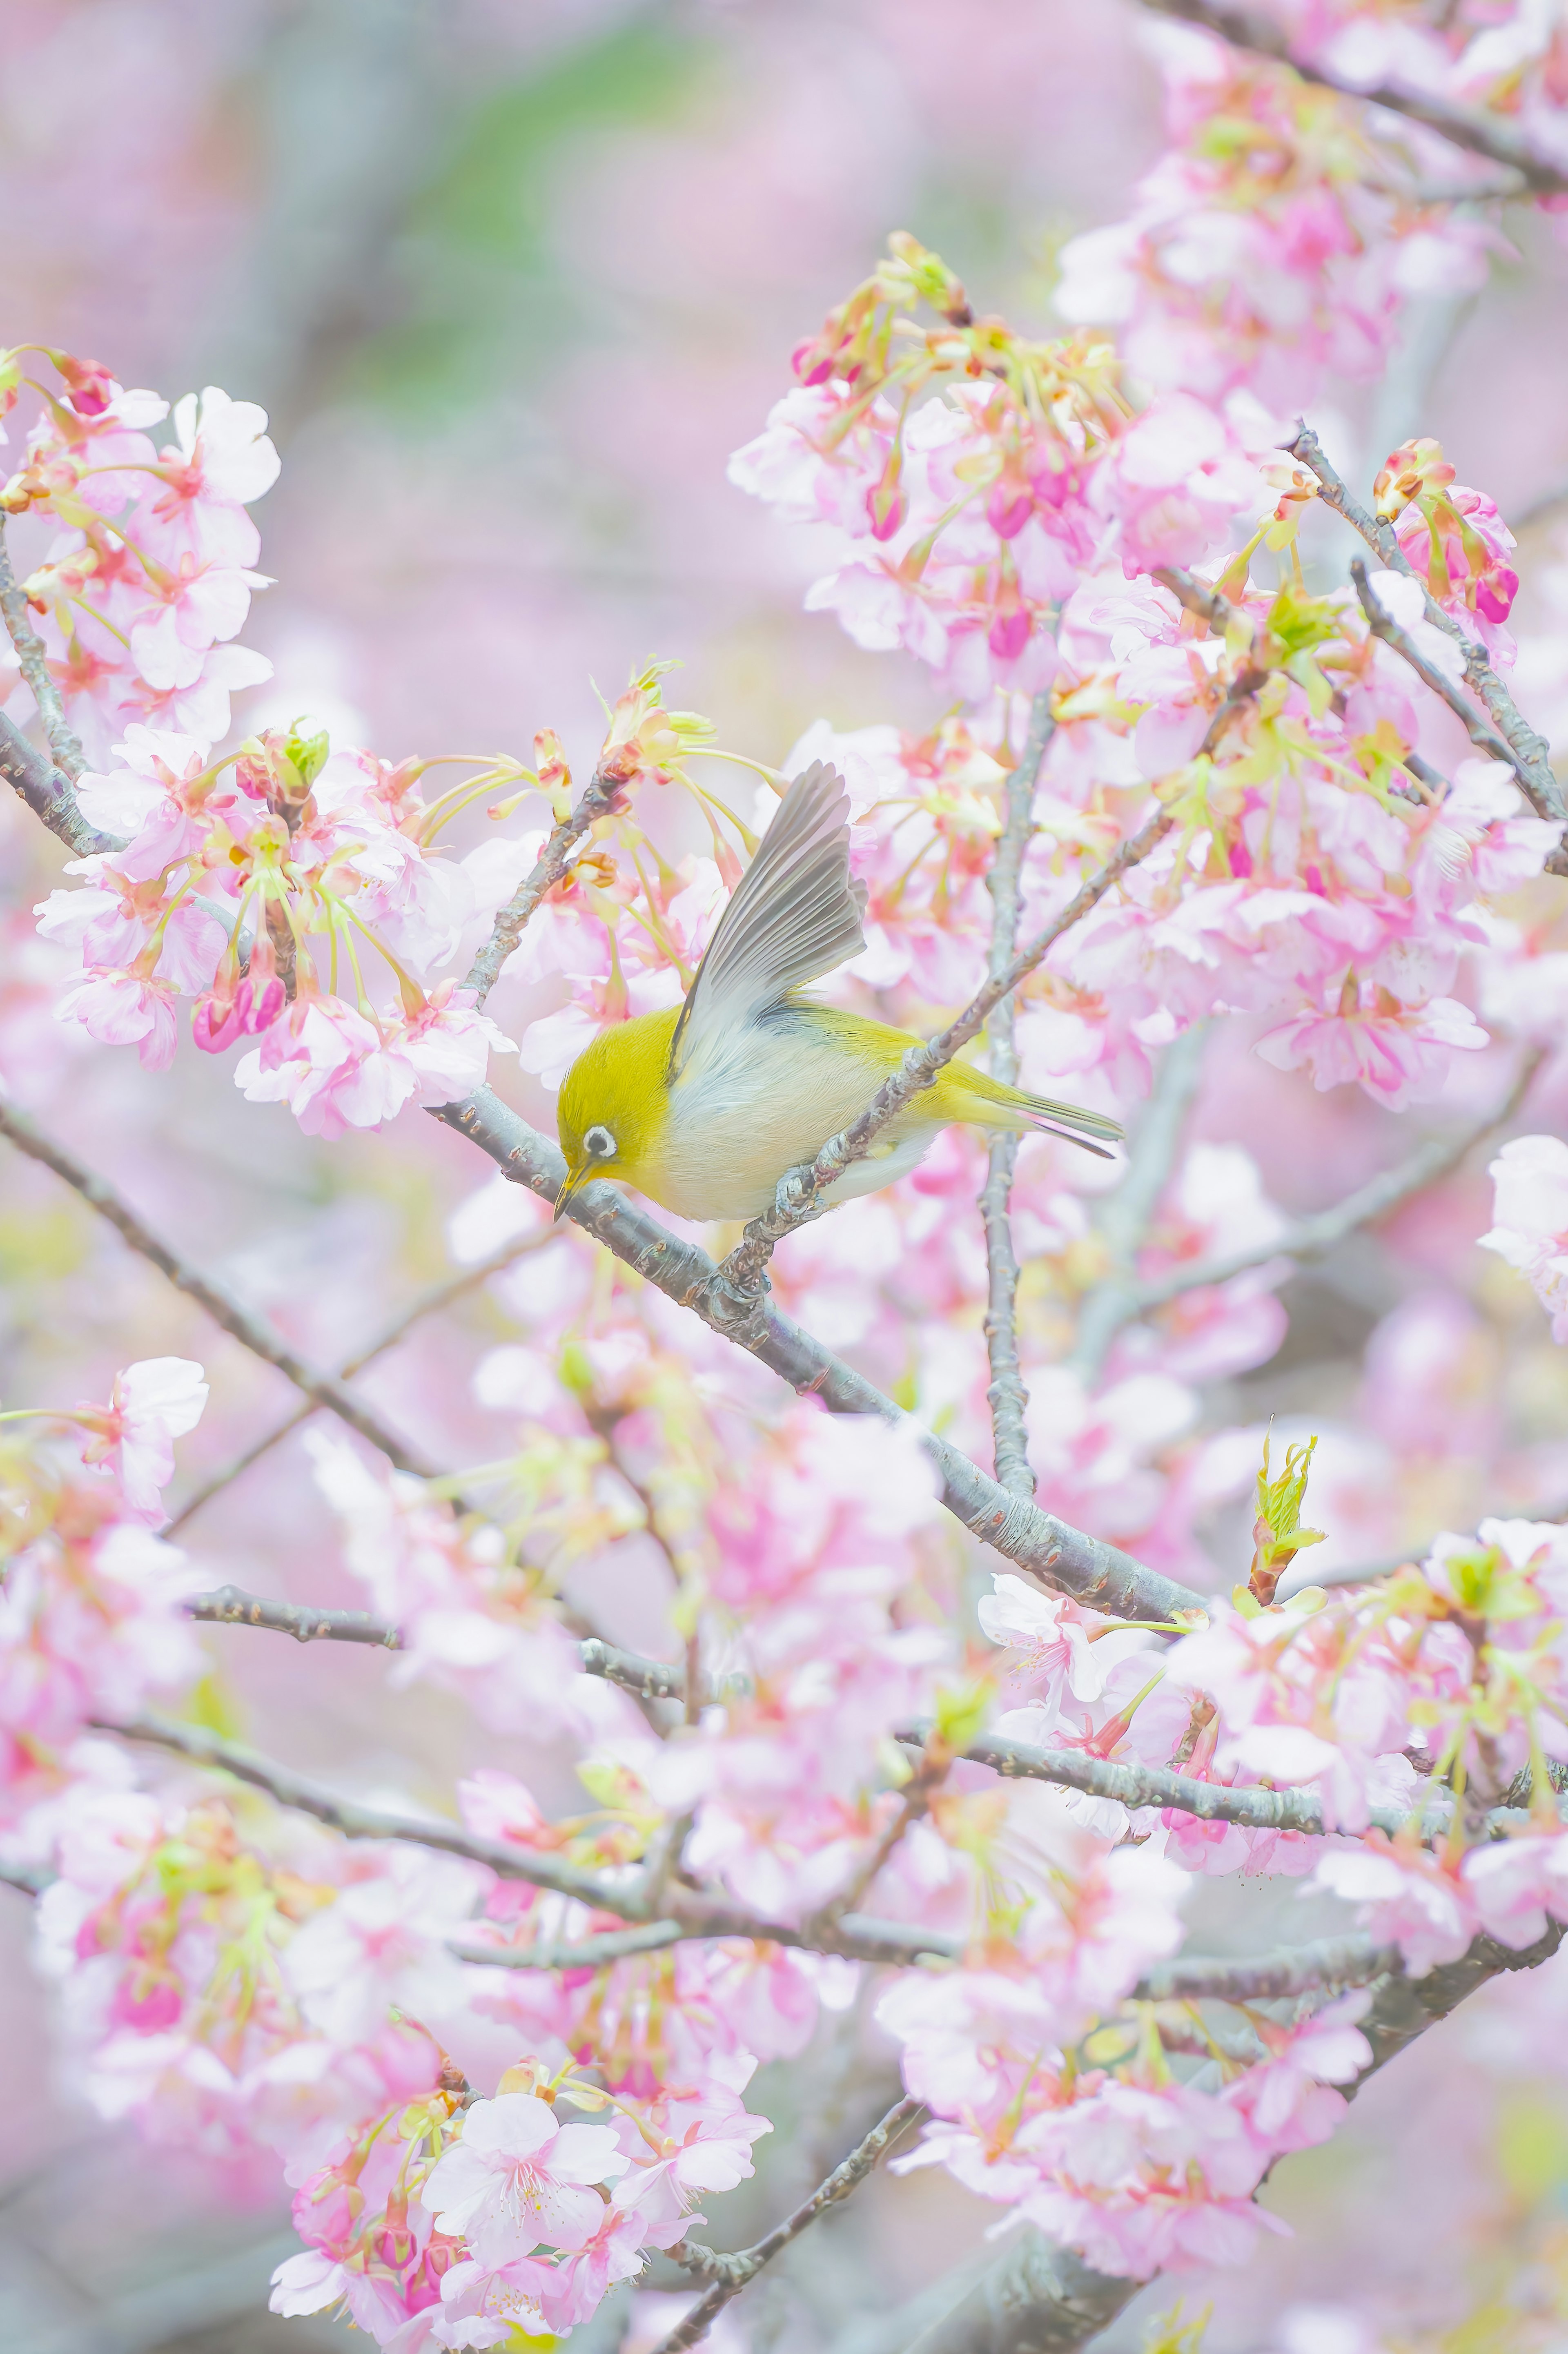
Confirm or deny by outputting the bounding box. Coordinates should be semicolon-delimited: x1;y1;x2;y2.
980;687;1057;1495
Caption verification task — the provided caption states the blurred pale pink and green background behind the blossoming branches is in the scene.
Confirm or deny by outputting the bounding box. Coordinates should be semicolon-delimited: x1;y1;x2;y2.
0;13;1568;2354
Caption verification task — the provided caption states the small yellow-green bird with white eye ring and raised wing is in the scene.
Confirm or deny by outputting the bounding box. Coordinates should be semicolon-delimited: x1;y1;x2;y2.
556;760;1121;1219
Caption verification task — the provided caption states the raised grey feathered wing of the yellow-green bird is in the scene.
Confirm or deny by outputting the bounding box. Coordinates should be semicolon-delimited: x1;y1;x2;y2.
668;760;866;1078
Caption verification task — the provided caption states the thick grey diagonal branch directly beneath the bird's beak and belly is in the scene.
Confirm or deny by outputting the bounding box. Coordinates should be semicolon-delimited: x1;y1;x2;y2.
423;1088;1203;1620
